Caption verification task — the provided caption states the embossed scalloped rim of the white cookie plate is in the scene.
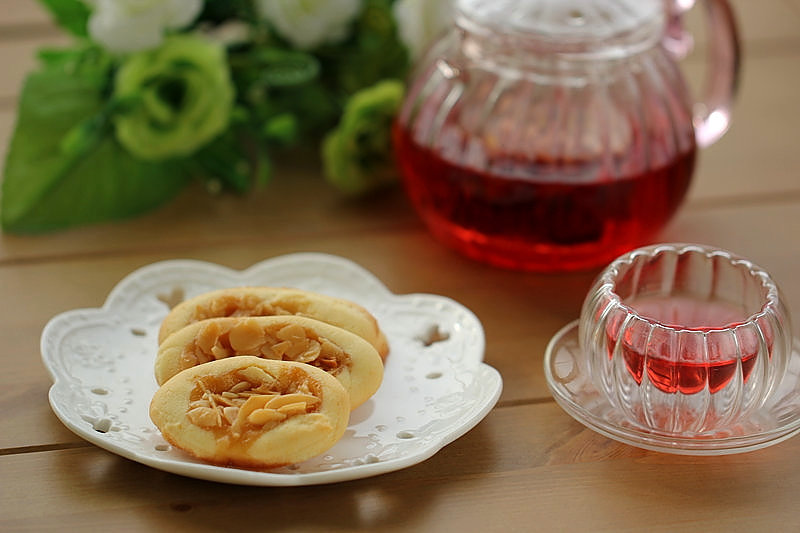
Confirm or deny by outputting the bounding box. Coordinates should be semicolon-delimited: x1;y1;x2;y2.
41;253;502;486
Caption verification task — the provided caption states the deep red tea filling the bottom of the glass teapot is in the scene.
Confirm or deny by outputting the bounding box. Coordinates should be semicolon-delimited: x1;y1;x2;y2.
394;126;695;271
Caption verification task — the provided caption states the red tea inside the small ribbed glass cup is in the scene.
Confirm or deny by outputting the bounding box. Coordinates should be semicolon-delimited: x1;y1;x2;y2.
606;297;772;394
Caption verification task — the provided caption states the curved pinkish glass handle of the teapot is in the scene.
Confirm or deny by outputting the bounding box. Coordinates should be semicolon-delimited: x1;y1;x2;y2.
664;0;741;147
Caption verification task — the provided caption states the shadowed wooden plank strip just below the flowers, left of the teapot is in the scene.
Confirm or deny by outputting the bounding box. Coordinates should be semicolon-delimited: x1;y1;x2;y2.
0;159;420;262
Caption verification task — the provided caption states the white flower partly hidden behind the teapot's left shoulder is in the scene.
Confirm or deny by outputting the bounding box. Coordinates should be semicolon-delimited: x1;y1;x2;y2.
392;0;455;60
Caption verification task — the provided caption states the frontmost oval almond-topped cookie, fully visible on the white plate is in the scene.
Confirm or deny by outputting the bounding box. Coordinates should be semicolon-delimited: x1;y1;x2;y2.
150;356;350;468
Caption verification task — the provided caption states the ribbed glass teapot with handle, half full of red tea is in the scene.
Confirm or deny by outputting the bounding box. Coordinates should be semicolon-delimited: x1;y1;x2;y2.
393;0;739;271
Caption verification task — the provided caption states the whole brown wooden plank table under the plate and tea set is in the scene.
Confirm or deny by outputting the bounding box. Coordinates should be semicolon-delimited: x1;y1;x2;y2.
0;0;800;531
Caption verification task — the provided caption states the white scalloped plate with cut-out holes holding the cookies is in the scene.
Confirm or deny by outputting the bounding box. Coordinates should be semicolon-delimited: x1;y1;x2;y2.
41;254;502;486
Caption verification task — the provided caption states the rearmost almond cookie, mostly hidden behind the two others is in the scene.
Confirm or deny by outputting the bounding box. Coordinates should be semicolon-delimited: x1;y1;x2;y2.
158;287;389;358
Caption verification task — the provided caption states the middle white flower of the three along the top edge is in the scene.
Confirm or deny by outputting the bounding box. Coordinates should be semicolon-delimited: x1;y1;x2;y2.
256;0;362;50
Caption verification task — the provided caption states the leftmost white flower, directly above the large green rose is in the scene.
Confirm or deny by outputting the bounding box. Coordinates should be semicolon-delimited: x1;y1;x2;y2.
85;0;203;52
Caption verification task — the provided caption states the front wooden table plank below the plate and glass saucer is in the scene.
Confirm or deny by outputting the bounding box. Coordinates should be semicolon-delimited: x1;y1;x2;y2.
0;404;800;532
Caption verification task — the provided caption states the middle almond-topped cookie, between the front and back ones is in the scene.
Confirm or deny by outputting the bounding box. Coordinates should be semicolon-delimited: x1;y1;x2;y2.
155;315;383;409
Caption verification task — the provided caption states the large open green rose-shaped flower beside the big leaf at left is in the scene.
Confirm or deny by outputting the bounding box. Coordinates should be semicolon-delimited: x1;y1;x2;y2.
114;36;234;159
